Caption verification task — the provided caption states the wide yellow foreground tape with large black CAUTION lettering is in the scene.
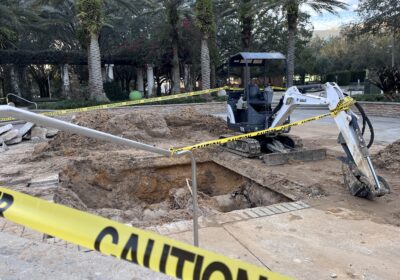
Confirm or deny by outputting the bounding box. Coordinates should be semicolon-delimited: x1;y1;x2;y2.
0;188;290;280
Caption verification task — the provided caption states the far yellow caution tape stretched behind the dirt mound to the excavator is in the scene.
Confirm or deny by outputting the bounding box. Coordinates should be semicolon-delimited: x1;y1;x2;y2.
0;87;227;122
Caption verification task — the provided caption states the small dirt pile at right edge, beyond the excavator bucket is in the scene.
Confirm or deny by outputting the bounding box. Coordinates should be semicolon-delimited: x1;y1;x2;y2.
373;140;400;171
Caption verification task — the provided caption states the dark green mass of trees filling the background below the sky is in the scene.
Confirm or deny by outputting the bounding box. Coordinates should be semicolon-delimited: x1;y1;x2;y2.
0;0;400;99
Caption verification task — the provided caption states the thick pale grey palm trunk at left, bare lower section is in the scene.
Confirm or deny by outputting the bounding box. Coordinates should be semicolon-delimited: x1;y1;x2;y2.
88;33;110;102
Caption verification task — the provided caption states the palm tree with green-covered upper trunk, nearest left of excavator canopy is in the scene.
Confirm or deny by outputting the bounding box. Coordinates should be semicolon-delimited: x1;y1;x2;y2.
196;0;215;89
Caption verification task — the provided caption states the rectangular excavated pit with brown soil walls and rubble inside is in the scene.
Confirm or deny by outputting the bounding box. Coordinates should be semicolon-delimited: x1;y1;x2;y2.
54;158;290;226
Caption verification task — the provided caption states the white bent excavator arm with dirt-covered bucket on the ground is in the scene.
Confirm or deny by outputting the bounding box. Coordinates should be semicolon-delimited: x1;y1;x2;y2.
270;83;390;199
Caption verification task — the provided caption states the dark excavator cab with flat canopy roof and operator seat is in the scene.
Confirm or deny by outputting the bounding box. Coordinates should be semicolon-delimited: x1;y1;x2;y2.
227;52;286;133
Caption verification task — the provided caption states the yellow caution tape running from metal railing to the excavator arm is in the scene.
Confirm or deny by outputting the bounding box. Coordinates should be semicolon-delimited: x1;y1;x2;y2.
170;97;356;154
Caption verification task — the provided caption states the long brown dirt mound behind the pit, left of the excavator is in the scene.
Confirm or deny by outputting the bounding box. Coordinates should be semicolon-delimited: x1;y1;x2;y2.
35;108;227;156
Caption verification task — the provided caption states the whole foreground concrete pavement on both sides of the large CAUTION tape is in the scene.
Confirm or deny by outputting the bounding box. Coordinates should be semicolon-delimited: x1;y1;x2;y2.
0;202;400;280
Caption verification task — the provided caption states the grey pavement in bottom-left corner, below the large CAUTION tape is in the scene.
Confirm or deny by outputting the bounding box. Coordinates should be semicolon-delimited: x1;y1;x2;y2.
0;232;172;280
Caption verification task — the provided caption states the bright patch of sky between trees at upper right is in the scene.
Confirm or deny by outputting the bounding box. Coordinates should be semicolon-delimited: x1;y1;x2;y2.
302;0;358;31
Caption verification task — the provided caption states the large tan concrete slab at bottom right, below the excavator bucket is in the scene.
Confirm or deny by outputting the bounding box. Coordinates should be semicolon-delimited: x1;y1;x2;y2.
222;209;400;280
